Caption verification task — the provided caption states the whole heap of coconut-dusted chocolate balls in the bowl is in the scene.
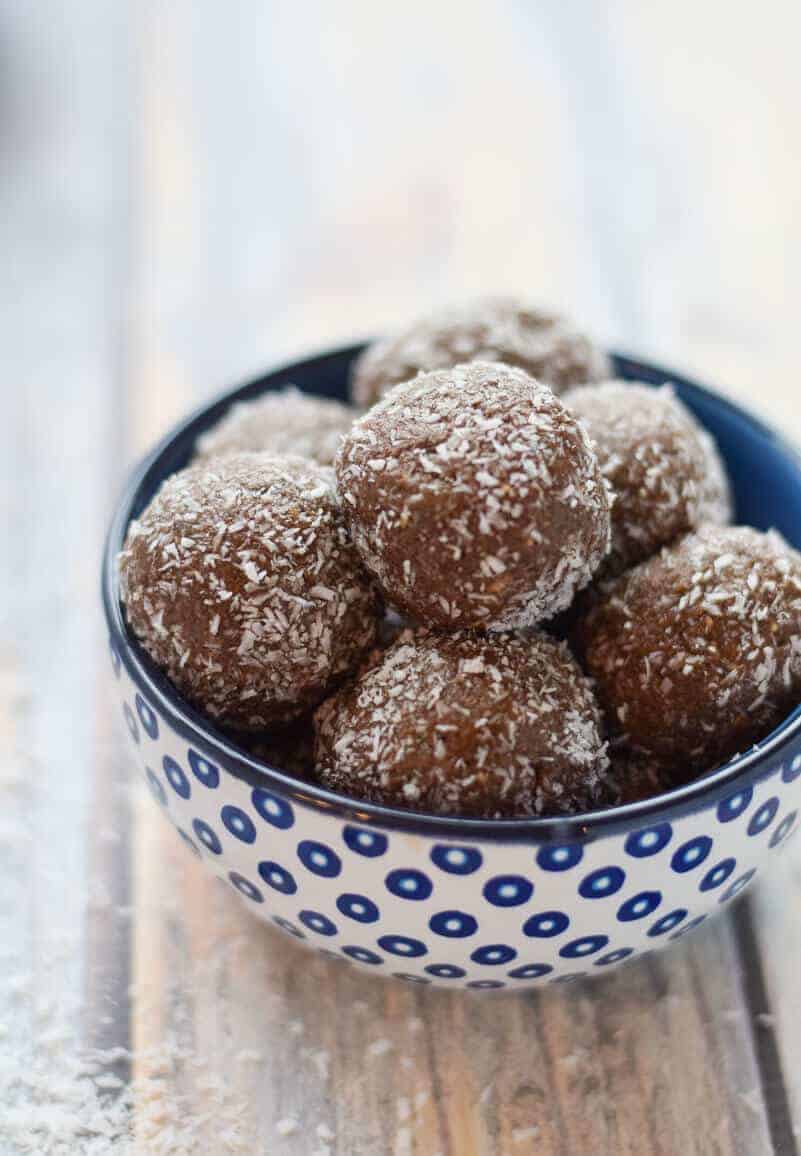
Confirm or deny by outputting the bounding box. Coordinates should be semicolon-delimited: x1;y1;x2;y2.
119;299;801;817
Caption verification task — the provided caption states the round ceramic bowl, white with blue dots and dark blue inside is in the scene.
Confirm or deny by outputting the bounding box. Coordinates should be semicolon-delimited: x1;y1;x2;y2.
103;347;801;991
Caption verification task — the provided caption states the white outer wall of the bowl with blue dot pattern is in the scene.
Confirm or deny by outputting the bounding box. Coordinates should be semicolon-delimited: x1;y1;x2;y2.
120;668;801;990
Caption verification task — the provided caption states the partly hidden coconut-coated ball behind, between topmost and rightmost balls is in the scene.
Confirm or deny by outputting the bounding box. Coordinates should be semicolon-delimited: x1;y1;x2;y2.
562;381;732;577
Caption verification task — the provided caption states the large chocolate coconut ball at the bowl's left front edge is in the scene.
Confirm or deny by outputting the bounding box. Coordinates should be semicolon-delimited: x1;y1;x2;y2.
119;453;378;731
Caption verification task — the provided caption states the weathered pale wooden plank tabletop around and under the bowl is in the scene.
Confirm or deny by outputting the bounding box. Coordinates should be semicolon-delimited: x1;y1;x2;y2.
0;0;801;1156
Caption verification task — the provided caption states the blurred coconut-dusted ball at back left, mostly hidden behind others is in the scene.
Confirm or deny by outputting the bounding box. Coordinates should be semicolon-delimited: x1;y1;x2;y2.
195;385;356;466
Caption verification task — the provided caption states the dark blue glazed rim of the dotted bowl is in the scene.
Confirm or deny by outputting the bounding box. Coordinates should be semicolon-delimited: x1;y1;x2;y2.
102;342;801;844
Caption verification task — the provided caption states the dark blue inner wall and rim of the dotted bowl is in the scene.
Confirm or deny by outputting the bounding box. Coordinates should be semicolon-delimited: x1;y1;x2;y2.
103;346;801;838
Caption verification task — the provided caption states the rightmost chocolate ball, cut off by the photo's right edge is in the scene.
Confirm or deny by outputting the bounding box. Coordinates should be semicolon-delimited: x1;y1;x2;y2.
579;526;801;770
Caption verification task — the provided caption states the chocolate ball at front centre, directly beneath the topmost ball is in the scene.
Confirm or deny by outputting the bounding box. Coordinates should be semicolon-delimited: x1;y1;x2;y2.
316;629;608;818
